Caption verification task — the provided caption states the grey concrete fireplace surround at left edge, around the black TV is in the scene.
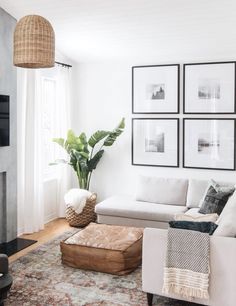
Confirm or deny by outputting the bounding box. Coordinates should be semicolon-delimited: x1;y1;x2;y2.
0;8;17;243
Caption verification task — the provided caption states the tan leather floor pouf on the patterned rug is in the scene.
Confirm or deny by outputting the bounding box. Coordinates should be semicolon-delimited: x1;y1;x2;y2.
61;223;143;275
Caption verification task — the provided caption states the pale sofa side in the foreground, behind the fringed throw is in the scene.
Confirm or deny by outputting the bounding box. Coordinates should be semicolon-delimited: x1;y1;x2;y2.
142;228;236;306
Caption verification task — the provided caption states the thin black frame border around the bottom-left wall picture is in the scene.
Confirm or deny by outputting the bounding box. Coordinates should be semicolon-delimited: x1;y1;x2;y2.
131;118;180;168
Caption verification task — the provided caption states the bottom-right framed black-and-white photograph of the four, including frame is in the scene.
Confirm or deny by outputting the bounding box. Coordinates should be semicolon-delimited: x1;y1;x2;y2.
183;118;235;170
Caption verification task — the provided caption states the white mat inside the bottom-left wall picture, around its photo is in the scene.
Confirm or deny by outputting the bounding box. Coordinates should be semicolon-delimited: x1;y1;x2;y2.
133;119;178;166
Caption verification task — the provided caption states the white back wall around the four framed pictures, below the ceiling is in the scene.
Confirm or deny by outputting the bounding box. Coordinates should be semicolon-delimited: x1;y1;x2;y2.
73;58;236;200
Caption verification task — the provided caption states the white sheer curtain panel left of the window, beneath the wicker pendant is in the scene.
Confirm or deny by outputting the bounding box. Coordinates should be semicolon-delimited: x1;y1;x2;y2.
17;69;44;233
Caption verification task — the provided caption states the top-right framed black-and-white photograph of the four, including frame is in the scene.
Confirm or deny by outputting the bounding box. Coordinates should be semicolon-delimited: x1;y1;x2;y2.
183;62;235;114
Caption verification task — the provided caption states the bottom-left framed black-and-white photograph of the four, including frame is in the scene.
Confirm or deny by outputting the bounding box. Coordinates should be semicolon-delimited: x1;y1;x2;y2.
132;118;179;167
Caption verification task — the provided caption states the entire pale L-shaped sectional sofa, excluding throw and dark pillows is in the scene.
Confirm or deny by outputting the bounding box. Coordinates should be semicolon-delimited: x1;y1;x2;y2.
96;177;236;306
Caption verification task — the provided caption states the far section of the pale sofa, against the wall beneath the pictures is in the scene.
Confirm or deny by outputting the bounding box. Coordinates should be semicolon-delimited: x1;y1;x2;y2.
95;177;209;228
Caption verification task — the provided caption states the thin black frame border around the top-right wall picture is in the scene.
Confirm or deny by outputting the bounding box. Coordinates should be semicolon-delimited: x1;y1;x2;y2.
183;61;236;115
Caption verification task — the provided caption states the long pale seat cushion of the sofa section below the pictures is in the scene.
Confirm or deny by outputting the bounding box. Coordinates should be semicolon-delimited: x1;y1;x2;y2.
95;196;187;222
